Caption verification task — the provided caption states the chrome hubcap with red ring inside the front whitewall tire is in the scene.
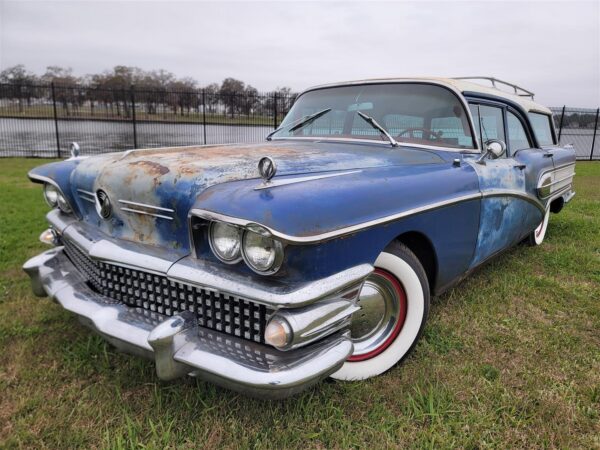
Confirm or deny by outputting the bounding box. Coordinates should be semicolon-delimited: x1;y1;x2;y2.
350;269;406;360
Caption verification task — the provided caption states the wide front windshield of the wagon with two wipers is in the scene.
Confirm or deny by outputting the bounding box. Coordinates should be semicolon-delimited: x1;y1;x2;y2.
273;83;474;149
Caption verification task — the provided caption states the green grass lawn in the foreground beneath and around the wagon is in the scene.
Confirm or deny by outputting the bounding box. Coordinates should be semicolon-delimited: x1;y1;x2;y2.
0;159;600;449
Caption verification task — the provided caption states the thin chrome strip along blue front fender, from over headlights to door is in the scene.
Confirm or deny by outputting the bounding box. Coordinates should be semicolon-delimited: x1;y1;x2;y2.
190;192;481;244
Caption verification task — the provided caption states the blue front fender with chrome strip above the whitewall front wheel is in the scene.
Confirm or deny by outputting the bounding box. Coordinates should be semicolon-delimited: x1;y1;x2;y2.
192;163;480;292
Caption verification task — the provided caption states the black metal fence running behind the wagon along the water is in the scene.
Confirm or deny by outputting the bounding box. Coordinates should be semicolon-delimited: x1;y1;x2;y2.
0;84;600;160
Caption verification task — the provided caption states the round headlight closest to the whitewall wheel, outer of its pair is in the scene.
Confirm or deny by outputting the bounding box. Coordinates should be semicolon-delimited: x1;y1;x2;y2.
242;231;283;274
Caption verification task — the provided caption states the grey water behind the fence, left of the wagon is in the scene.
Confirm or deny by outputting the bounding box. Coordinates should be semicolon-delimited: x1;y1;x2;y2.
0;118;273;157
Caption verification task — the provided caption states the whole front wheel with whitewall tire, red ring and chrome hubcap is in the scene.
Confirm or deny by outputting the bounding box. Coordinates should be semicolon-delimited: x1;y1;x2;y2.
331;242;430;380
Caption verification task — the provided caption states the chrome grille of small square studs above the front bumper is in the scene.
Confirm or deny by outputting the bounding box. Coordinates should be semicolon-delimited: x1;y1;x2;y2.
64;240;267;343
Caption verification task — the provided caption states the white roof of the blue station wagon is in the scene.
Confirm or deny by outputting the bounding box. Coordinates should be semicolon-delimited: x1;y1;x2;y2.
307;77;552;114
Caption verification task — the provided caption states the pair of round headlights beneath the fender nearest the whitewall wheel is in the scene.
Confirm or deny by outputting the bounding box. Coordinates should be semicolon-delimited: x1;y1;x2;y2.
208;222;283;275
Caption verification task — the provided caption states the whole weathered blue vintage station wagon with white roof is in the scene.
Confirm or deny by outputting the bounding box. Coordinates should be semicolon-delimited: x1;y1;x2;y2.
24;78;575;398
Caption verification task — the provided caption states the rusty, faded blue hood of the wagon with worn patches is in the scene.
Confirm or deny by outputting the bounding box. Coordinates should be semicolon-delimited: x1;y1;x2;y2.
71;141;443;250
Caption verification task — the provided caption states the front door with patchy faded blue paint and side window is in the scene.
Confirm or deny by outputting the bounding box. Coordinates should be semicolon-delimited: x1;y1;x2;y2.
470;102;552;267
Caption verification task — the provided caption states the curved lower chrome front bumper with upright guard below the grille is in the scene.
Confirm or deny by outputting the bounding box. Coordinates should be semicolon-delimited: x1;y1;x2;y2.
23;247;353;398
